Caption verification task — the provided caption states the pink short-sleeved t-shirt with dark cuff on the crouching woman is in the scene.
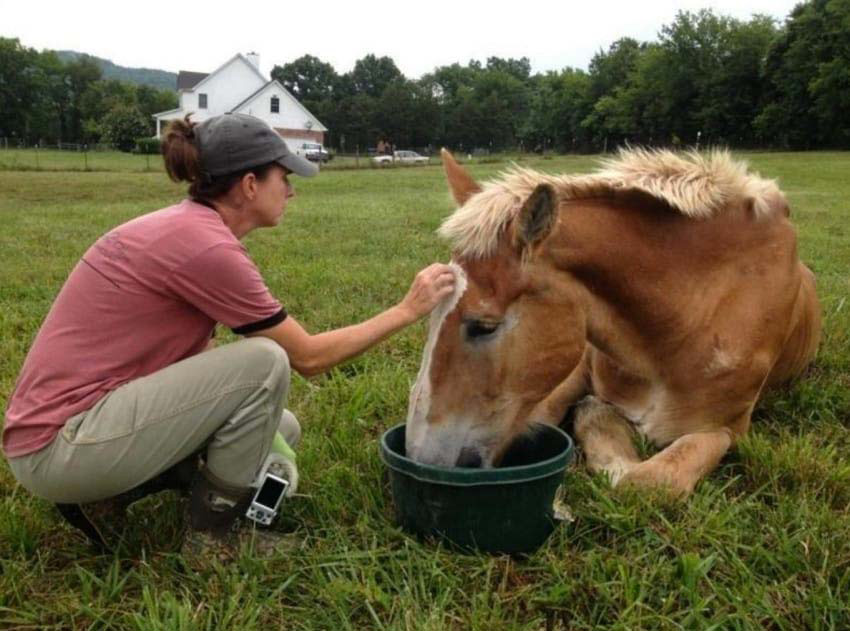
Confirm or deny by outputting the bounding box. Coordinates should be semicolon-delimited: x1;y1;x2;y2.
3;200;286;457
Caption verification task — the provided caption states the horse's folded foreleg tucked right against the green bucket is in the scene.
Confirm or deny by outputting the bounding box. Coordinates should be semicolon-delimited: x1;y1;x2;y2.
573;397;640;486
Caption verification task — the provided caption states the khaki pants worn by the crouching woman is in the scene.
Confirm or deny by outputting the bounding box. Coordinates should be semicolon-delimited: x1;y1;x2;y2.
9;337;301;504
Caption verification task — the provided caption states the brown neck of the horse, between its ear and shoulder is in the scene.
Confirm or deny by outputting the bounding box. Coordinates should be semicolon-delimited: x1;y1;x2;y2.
549;199;744;373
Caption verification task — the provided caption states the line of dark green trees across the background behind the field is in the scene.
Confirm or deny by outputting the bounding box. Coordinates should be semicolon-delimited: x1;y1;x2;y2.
0;0;850;152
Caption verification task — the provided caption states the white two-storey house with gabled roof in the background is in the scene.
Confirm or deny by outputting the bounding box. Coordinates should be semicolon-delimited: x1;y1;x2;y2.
154;53;327;151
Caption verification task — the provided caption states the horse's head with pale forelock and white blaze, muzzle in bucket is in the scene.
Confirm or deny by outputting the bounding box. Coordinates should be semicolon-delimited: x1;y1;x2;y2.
406;150;585;467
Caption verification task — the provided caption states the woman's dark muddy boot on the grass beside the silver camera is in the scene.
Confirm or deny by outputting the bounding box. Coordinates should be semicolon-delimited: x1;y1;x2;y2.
181;469;290;571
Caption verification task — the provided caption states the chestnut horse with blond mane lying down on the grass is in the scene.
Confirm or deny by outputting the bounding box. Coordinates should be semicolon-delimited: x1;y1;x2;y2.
406;150;820;495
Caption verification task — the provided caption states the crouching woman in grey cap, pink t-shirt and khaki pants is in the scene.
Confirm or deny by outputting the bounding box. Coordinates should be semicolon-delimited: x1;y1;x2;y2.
3;114;454;555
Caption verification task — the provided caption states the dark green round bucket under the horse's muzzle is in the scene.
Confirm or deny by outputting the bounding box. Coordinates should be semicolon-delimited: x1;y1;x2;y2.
381;424;573;554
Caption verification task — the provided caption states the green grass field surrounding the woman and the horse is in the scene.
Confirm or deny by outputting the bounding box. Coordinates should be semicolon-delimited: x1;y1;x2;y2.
0;152;850;631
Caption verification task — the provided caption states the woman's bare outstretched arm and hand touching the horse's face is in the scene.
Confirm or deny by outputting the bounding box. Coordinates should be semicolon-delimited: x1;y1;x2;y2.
245;263;455;377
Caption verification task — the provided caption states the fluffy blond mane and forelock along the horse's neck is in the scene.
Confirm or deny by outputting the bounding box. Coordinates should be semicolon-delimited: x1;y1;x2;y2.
439;148;779;258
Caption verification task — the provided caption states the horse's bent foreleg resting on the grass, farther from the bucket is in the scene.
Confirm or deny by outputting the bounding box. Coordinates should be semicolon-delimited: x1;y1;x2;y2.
619;428;733;497
